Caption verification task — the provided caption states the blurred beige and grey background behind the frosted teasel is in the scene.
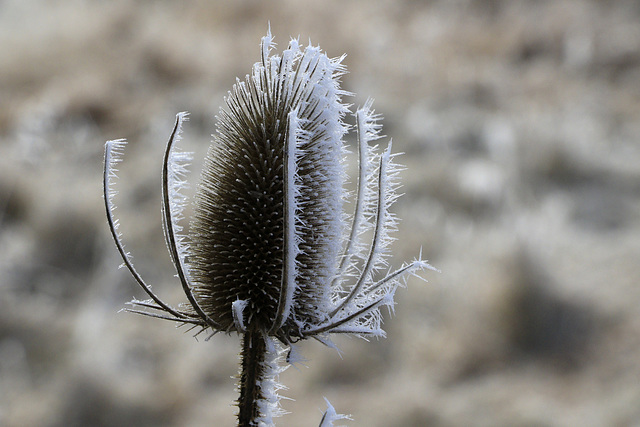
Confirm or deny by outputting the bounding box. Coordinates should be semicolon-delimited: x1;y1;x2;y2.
0;0;640;427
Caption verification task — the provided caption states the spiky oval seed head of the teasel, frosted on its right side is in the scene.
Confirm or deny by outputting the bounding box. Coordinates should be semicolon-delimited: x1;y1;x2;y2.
189;33;347;342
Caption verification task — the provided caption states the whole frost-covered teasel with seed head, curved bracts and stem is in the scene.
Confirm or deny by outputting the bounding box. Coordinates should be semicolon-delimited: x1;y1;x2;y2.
104;32;433;426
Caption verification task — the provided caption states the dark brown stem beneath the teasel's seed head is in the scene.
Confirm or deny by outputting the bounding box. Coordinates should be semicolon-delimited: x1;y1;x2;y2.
238;328;267;427
